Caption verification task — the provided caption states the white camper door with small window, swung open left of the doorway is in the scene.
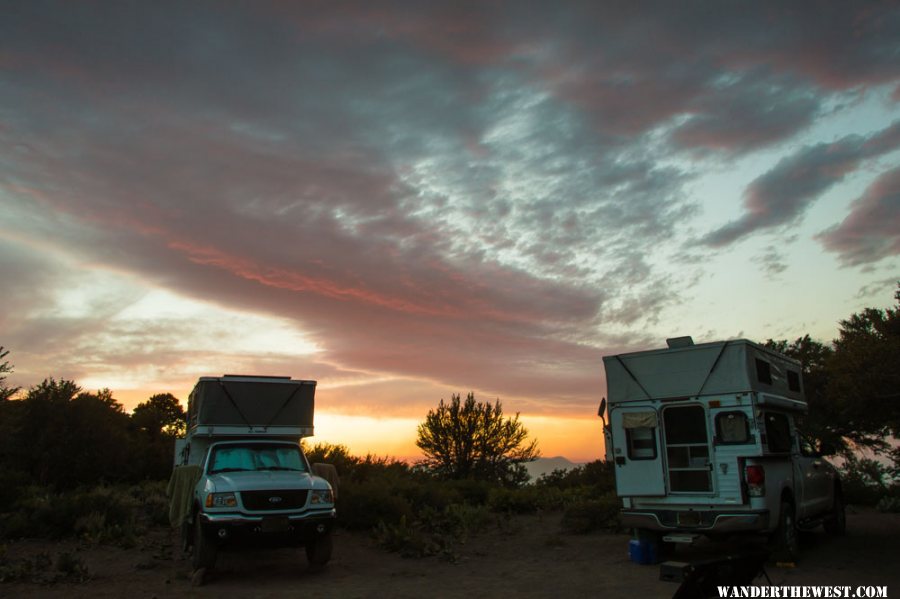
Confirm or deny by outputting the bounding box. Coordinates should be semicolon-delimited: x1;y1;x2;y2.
609;406;666;497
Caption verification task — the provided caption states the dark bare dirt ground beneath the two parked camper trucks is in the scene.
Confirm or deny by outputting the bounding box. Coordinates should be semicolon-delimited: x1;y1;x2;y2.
0;511;900;599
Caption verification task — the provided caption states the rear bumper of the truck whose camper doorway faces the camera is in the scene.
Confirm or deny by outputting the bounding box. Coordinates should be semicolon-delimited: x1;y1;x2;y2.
619;510;769;533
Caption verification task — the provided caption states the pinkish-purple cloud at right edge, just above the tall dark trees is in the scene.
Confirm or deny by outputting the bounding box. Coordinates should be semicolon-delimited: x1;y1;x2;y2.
816;168;900;266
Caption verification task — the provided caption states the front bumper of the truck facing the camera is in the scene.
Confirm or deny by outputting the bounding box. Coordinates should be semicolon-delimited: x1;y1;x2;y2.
199;508;336;546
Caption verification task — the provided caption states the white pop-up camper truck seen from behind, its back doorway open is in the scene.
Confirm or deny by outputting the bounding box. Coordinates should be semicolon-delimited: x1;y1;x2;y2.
601;337;845;559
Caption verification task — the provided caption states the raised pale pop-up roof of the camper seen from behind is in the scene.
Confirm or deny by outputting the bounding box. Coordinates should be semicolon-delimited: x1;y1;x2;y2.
603;339;804;404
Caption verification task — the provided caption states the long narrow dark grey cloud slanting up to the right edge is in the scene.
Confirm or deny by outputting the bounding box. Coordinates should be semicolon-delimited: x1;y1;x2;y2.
703;122;900;247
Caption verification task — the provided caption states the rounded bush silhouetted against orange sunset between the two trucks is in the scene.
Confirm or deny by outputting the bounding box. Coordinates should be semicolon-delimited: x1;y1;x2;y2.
416;393;540;484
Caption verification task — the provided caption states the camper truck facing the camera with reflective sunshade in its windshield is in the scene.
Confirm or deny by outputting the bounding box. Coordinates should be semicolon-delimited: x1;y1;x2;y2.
169;375;335;571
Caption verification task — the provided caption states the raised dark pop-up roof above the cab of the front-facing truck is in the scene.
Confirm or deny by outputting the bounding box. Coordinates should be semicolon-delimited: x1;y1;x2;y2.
188;376;316;434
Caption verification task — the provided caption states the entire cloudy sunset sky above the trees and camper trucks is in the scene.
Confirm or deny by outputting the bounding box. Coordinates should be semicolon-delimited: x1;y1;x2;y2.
0;0;900;461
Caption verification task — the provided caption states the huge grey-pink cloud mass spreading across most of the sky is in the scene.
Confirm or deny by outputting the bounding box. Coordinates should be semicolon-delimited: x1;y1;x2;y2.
0;1;900;418
